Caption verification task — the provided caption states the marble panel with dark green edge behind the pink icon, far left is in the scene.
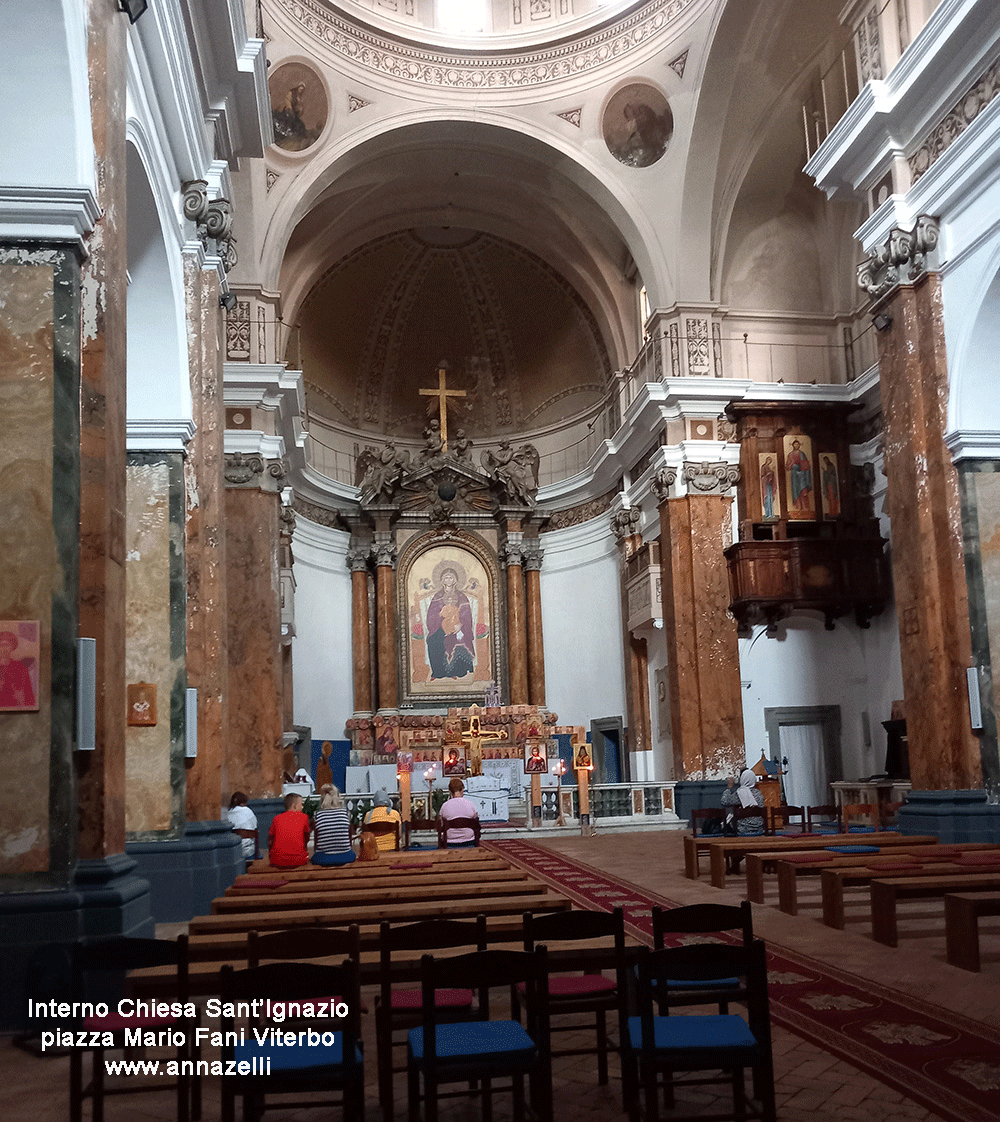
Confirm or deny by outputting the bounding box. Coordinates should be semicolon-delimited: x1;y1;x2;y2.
0;246;80;891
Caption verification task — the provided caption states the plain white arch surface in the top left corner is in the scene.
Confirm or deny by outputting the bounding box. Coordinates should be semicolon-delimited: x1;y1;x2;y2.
0;0;95;190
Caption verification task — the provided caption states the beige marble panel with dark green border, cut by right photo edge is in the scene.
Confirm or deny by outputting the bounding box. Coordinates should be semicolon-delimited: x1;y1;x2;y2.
958;460;1000;800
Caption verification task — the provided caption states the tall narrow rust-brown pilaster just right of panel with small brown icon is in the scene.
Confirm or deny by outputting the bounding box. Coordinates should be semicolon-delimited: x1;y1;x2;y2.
184;254;230;822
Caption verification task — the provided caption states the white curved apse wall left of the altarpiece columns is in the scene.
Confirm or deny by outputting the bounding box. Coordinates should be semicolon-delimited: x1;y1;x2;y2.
292;515;355;741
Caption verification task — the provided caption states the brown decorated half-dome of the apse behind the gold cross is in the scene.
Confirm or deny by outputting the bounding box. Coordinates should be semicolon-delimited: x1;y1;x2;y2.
299;227;612;440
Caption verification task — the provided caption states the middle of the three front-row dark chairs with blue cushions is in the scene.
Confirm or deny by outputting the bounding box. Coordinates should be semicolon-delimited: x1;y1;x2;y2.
406;947;552;1122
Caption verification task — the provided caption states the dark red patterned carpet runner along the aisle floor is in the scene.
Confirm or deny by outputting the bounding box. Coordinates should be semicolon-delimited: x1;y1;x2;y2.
484;838;1000;1122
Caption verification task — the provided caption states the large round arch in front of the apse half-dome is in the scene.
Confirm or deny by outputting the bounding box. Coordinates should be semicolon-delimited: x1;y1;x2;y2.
260;113;670;365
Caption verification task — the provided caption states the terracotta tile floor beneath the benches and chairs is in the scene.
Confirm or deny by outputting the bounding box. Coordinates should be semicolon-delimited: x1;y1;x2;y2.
0;831;1000;1122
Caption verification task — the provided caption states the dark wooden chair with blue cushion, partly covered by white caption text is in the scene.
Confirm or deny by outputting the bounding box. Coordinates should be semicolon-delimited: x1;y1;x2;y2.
220;958;365;1122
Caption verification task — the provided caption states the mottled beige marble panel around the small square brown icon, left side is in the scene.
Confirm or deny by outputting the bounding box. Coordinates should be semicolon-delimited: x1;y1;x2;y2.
125;452;187;840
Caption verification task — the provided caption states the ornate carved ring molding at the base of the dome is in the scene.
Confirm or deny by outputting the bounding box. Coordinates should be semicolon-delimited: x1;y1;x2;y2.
275;0;699;92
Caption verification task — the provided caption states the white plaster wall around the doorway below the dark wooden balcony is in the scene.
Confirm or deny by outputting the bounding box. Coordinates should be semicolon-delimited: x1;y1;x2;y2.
740;610;902;779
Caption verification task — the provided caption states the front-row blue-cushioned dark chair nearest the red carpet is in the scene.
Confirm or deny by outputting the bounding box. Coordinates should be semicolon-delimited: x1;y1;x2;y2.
621;939;776;1122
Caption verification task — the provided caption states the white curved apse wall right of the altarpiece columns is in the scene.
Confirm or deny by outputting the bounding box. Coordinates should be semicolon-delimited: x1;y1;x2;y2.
541;516;625;728
